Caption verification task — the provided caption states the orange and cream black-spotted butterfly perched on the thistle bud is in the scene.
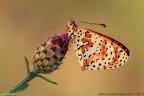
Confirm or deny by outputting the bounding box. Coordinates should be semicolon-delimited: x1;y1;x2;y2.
66;19;130;71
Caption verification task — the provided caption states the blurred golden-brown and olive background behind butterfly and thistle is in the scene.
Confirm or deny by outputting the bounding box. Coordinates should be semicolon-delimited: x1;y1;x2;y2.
0;0;144;96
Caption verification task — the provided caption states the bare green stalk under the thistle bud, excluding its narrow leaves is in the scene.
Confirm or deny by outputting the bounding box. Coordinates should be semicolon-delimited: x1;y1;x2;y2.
6;70;38;93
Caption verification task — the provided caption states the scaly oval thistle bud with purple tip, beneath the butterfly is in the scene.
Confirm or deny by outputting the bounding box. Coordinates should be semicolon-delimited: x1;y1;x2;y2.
32;33;69;74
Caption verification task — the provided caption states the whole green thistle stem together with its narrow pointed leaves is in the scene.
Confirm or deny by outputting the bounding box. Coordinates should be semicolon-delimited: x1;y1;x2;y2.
0;57;57;96
